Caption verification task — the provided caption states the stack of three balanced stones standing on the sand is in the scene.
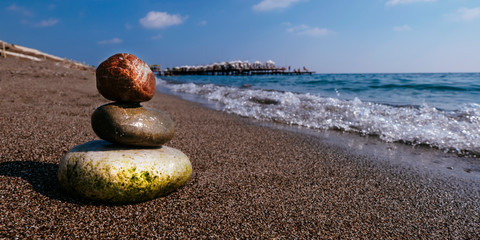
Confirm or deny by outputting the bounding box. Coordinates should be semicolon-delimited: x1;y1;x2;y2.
58;53;192;203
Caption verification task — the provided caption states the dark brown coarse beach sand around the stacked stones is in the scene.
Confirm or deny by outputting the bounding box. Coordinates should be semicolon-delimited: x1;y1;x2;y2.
0;57;480;239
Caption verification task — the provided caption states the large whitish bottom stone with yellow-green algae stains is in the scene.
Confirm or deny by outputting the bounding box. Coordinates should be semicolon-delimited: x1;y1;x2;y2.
58;140;192;203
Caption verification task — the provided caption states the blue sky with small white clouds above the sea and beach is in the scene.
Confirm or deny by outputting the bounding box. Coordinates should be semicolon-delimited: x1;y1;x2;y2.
0;0;480;73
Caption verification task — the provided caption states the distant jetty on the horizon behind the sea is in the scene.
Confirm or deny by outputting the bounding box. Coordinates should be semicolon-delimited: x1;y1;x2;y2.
150;60;315;76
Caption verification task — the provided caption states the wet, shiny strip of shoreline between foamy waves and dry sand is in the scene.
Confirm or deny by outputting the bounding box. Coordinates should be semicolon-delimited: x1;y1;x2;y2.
157;82;480;182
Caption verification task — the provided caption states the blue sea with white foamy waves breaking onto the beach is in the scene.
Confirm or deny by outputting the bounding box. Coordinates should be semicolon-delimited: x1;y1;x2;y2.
157;73;480;157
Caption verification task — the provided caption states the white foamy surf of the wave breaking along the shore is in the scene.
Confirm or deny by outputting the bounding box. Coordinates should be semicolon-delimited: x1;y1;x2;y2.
159;80;480;153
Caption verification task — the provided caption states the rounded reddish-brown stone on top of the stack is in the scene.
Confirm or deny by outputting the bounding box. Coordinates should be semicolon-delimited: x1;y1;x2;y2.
96;53;155;103
